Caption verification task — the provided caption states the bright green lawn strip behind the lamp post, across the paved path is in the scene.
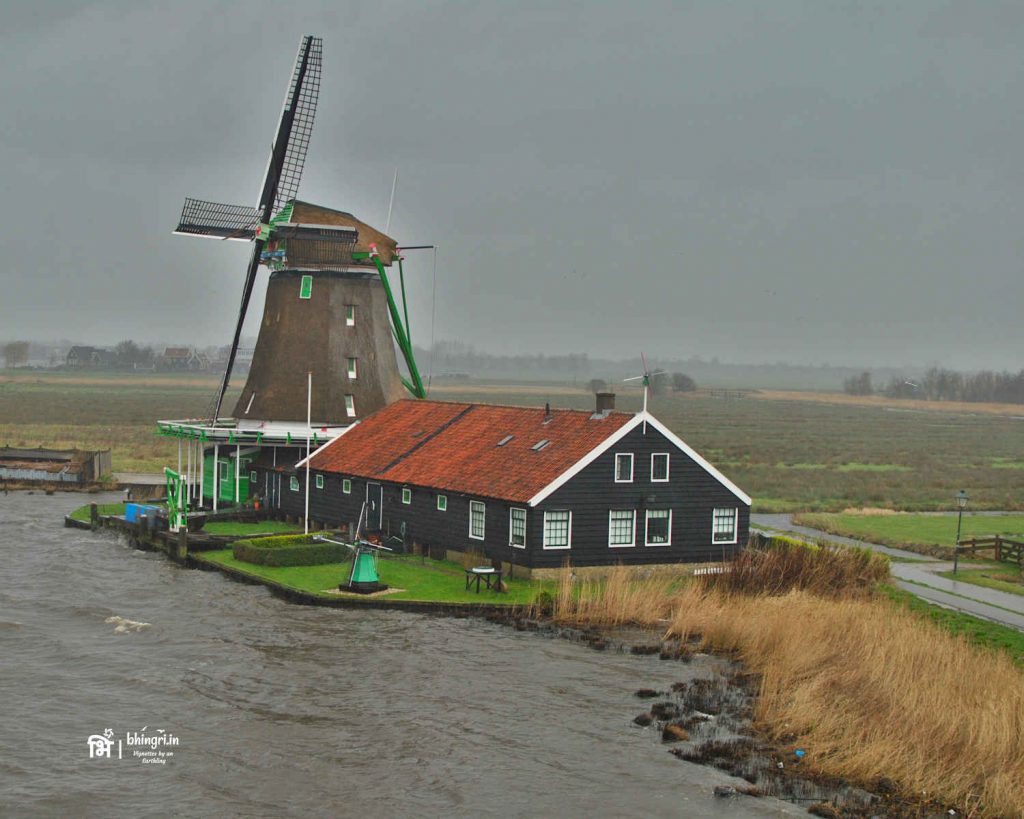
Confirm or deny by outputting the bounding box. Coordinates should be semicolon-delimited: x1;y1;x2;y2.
794;513;1024;549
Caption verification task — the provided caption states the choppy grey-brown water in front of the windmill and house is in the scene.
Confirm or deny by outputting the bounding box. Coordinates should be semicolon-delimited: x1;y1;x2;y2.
0;492;806;817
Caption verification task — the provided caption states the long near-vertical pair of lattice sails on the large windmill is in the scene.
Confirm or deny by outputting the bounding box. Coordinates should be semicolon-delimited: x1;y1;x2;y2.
207;35;324;424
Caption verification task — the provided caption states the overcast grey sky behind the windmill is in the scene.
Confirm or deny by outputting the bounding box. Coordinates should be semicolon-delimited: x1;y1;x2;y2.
0;0;1024;370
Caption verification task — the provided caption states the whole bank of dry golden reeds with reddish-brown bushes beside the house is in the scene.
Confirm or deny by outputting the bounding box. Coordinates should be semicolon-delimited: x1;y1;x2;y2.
551;543;1024;817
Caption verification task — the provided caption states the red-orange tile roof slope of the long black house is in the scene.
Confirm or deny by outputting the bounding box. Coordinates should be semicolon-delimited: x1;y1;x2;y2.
310;399;634;503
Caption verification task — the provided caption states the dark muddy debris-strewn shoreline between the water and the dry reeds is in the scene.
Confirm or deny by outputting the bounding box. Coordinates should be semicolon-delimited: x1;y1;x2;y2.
480;610;965;819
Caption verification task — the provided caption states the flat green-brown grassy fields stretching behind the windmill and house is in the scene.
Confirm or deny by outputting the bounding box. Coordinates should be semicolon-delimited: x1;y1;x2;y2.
0;371;1024;512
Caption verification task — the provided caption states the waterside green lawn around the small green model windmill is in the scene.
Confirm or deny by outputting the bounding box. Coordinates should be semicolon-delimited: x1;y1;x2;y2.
203;549;554;604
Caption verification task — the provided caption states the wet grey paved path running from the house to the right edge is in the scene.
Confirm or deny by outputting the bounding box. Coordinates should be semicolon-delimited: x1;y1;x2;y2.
751;515;1024;632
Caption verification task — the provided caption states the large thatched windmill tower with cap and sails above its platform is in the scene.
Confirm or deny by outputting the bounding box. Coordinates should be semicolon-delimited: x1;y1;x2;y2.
174;35;426;427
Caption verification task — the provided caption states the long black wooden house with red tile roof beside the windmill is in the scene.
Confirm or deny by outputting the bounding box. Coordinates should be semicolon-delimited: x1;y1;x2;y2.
250;394;751;568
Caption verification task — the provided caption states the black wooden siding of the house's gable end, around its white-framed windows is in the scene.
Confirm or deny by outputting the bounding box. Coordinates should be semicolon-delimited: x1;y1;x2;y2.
526;425;751;567
